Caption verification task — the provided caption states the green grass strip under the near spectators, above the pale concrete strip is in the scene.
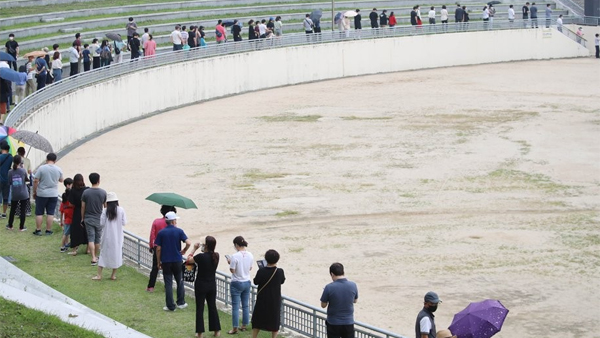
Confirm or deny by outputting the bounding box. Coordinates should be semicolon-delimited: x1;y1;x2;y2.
0;217;270;338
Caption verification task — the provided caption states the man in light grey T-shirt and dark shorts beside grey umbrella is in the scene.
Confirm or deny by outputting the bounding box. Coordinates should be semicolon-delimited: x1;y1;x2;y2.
33;153;63;236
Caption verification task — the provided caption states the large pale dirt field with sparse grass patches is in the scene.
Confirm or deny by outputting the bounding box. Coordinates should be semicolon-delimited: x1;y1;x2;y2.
59;59;600;338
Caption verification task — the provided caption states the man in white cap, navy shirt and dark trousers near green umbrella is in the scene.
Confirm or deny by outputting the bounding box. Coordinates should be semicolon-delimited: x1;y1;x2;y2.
154;211;192;311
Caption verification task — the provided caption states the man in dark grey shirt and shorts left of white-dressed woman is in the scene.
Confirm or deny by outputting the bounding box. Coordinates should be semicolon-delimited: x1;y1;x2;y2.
81;173;106;265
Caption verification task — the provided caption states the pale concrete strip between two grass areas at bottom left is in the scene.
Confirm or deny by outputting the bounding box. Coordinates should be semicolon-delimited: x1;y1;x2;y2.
0;257;149;338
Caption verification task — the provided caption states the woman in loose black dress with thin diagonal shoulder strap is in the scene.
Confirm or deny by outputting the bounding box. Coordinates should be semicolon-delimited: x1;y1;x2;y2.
252;249;285;338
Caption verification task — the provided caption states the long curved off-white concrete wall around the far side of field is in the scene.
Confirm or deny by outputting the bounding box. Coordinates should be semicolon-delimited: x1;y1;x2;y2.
15;29;589;165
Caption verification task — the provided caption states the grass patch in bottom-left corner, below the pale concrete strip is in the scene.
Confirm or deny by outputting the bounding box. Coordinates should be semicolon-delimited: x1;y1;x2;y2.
0;297;102;338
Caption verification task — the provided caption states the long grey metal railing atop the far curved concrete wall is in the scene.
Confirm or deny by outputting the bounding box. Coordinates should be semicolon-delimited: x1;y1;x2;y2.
5;18;585;127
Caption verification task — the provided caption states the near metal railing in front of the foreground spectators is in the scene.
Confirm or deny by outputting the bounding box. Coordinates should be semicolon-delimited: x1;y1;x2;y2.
123;231;406;338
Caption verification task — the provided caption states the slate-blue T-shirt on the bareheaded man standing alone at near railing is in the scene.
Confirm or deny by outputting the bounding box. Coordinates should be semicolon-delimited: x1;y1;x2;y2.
321;278;358;325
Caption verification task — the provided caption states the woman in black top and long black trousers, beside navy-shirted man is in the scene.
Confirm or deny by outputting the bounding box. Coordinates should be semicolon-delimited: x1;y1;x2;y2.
187;236;221;338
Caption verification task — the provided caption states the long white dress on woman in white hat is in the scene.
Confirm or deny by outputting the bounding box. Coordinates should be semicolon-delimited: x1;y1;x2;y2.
98;207;127;269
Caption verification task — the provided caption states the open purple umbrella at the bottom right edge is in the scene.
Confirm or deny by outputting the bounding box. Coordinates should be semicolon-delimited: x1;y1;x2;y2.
448;299;508;338
